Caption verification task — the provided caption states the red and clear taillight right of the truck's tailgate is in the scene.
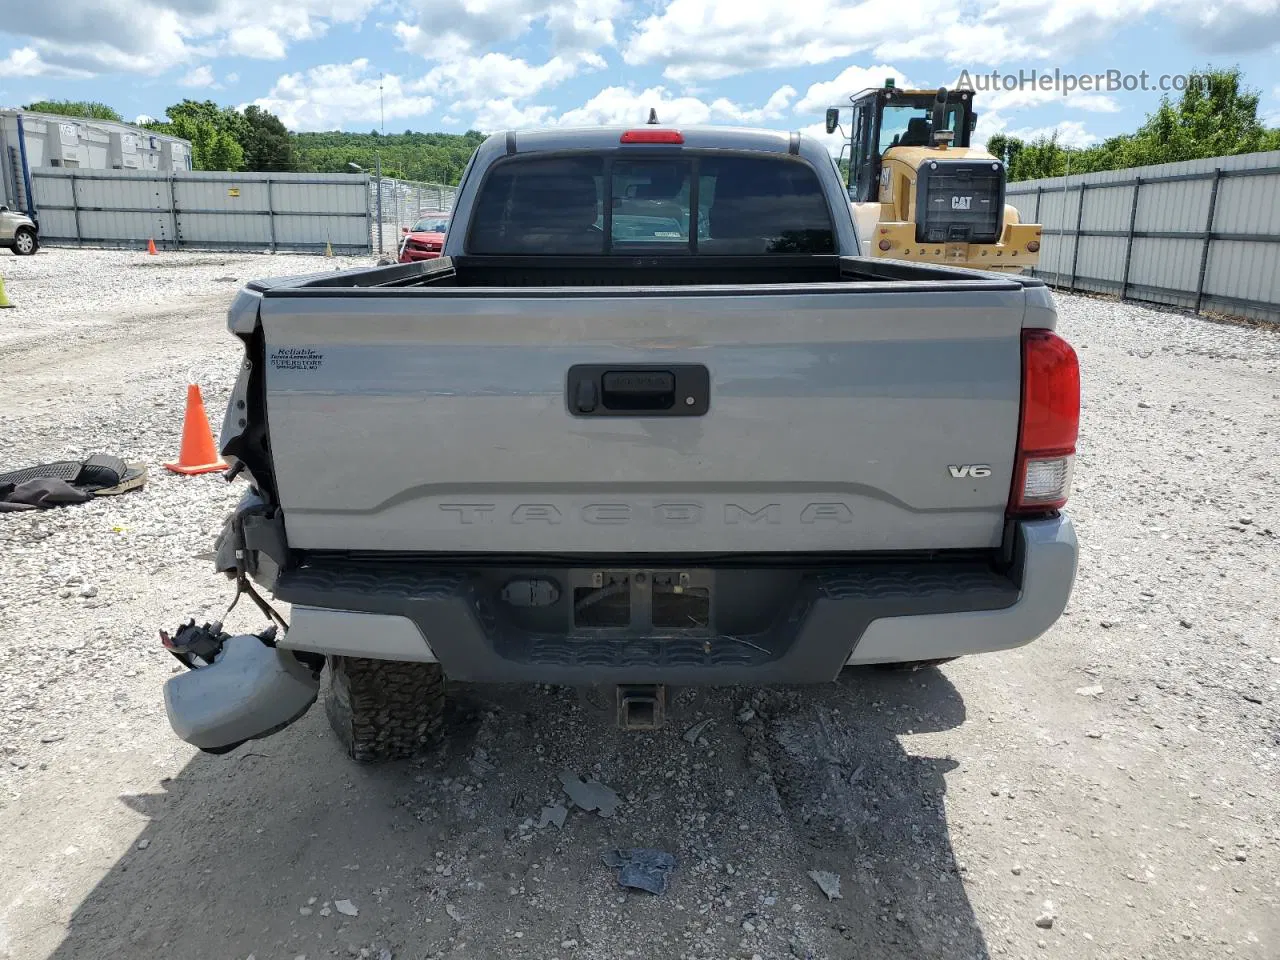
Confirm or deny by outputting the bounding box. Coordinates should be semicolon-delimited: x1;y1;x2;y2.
1009;330;1080;513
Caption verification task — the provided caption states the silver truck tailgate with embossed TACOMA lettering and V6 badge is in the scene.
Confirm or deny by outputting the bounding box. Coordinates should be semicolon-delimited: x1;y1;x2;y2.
260;284;1025;554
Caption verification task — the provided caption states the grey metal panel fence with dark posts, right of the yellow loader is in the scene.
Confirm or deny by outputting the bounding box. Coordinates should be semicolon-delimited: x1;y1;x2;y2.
1006;152;1280;320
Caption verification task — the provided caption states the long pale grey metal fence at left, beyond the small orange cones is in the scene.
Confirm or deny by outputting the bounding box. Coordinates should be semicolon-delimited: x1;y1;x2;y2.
31;166;371;253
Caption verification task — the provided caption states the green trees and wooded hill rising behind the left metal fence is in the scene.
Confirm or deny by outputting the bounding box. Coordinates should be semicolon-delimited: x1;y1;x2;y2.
23;100;485;184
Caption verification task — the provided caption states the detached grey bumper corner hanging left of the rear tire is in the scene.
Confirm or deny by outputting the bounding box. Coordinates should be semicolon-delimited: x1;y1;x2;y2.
164;634;320;754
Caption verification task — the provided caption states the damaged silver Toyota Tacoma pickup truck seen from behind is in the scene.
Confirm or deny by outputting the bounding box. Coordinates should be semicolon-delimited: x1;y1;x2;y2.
166;125;1079;759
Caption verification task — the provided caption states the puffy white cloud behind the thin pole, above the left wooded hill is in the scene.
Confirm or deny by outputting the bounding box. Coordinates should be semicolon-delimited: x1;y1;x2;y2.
253;58;435;131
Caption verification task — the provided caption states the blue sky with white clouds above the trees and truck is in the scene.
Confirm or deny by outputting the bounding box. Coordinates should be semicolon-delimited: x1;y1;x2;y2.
0;0;1280;152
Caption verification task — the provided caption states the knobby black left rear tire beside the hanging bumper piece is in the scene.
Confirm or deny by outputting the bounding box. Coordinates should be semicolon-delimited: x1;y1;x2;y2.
325;657;444;763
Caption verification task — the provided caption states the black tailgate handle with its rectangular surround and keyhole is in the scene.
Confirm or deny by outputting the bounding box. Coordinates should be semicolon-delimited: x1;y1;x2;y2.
566;364;712;417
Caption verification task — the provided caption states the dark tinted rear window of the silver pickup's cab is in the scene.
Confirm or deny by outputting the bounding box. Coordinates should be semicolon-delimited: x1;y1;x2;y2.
467;152;836;256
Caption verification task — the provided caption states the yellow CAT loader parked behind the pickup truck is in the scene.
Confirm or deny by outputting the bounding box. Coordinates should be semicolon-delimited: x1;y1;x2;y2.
827;79;1041;273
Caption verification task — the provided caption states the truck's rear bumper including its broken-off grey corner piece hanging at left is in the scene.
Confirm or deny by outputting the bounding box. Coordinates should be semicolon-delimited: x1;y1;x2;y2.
165;516;1078;753
